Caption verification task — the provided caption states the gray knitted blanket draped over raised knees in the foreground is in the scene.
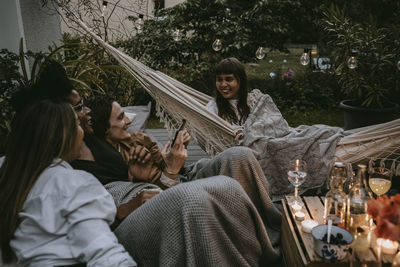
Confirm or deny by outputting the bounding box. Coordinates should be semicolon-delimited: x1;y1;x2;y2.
106;147;281;266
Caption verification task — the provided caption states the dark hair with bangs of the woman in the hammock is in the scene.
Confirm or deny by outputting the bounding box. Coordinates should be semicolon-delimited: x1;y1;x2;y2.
214;57;250;125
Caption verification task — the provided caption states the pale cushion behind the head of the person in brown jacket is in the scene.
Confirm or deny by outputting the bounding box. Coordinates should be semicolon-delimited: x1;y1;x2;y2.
123;102;151;133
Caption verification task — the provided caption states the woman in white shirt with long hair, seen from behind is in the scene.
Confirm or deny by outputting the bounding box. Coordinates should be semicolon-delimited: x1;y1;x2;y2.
0;100;136;266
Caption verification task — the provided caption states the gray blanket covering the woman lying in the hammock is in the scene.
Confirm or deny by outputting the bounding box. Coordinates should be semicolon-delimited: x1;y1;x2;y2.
241;94;344;201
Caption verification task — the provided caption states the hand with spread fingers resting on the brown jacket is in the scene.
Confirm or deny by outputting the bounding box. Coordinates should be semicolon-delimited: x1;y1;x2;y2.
128;145;153;182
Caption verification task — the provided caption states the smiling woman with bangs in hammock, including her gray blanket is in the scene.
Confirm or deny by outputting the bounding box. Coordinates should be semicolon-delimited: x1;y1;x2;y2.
206;58;346;201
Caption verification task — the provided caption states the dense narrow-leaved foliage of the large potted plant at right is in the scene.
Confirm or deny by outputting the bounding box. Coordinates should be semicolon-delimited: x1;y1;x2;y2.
321;3;400;108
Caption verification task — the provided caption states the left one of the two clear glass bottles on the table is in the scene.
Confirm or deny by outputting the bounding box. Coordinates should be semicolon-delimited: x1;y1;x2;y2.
323;162;347;228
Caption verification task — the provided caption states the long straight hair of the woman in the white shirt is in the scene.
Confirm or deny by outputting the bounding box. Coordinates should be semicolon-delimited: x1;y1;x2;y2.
0;100;78;262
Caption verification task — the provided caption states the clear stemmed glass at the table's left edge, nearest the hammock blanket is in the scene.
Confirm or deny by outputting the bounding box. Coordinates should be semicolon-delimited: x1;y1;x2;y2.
288;159;307;209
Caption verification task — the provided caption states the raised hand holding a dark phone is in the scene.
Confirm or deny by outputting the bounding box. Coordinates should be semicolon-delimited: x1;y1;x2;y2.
161;131;190;178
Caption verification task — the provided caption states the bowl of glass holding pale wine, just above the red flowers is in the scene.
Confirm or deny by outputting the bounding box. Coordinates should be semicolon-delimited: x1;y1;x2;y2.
368;167;393;196
